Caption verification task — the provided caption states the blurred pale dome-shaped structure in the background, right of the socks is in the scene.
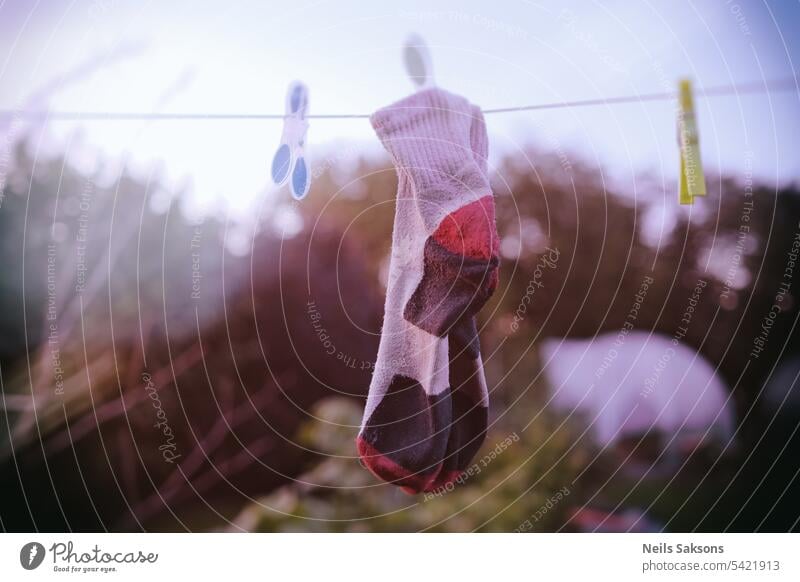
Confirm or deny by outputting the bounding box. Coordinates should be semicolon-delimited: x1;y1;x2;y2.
540;332;736;446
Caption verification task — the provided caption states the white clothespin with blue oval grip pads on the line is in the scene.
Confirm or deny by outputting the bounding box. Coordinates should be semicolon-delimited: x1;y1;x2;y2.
272;81;311;200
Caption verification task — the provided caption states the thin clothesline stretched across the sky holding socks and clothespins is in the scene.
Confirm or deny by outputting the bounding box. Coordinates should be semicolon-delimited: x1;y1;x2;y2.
0;77;800;121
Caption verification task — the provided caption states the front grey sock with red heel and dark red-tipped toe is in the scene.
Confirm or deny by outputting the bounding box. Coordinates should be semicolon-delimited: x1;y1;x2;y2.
357;88;498;493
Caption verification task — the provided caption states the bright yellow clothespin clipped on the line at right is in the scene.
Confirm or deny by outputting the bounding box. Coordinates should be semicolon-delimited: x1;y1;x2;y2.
678;79;706;204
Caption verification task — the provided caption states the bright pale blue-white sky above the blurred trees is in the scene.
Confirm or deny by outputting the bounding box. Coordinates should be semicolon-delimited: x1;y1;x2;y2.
0;0;800;216
